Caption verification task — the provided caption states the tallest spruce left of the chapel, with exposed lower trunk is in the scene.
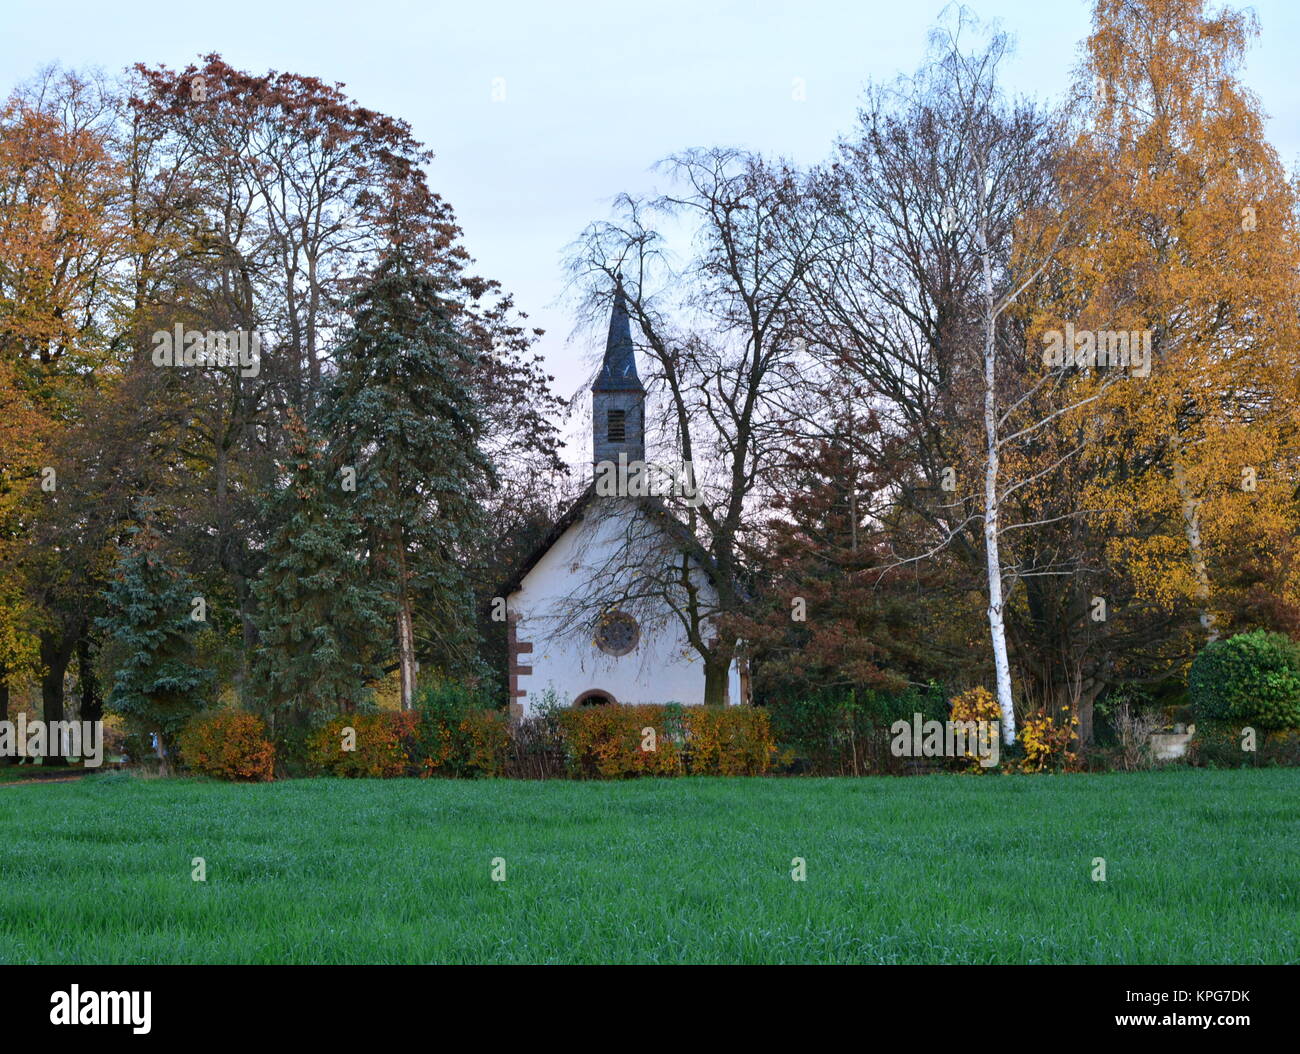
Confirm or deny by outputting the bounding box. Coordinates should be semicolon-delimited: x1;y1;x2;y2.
325;247;493;708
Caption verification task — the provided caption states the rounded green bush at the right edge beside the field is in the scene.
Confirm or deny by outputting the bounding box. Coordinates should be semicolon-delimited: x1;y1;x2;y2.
1187;630;1300;729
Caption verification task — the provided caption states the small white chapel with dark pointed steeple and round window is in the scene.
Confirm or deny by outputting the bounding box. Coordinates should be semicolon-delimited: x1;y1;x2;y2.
504;283;748;717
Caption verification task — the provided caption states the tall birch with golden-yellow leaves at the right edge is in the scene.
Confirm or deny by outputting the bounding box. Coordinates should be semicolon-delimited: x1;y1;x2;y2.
1062;0;1300;639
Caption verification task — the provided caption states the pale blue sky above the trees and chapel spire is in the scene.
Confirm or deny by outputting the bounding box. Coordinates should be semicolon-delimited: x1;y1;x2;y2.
0;0;1300;413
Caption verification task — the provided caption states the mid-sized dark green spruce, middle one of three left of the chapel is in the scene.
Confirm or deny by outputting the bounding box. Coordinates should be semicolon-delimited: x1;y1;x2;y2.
252;413;391;746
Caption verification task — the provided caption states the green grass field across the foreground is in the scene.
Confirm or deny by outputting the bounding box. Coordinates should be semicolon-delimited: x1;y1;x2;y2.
0;769;1300;963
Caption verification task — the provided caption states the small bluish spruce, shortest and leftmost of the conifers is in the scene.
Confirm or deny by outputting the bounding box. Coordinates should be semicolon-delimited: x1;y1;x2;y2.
98;521;213;775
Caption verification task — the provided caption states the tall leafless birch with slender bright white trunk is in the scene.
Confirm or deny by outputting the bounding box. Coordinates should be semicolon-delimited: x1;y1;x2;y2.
802;16;1118;742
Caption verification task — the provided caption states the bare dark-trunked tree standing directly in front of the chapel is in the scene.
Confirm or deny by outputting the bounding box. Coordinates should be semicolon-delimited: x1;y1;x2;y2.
569;149;811;703
